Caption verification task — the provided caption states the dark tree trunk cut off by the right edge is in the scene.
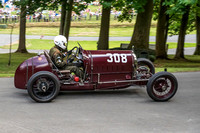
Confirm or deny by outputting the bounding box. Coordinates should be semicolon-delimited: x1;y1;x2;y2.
194;15;200;55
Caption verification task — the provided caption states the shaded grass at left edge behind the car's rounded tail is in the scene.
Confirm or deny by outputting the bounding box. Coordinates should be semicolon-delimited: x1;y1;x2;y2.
0;53;36;77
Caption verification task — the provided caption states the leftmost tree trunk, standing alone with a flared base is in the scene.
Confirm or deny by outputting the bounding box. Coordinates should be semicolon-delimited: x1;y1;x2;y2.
16;3;28;53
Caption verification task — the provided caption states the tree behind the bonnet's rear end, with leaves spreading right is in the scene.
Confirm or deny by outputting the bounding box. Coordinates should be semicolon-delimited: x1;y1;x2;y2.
98;0;149;49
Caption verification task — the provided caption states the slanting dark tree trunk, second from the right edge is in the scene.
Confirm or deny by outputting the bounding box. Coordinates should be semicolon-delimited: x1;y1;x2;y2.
175;6;190;59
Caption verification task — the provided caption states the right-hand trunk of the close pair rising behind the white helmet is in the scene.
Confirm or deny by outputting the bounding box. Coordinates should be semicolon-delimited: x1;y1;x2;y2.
64;0;73;41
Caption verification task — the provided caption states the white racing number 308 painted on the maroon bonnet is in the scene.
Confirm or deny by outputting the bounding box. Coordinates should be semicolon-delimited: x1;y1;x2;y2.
106;53;127;63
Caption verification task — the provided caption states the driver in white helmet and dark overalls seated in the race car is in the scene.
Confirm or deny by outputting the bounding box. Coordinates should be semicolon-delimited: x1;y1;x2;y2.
49;35;83;78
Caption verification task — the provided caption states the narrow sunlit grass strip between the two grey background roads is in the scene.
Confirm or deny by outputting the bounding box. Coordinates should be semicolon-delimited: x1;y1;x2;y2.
0;39;196;50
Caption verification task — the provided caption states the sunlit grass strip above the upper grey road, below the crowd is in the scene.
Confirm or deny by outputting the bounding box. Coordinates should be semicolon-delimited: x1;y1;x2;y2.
0;27;159;37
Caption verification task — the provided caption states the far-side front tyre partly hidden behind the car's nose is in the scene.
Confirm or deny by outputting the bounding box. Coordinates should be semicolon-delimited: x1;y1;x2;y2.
137;58;155;74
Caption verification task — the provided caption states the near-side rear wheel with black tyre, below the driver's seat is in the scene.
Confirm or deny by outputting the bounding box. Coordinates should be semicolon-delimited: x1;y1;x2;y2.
27;71;60;103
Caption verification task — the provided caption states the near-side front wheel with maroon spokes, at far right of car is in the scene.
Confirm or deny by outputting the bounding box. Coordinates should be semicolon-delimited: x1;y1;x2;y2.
147;72;178;102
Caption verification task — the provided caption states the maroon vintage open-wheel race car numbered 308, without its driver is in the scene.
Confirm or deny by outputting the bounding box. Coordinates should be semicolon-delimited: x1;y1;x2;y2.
14;44;178;102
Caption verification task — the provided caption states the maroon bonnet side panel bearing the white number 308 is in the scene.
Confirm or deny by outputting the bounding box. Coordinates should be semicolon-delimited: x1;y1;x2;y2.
83;50;134;89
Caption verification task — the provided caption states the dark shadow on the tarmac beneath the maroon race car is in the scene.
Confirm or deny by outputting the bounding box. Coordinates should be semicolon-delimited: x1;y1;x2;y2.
16;87;152;103
